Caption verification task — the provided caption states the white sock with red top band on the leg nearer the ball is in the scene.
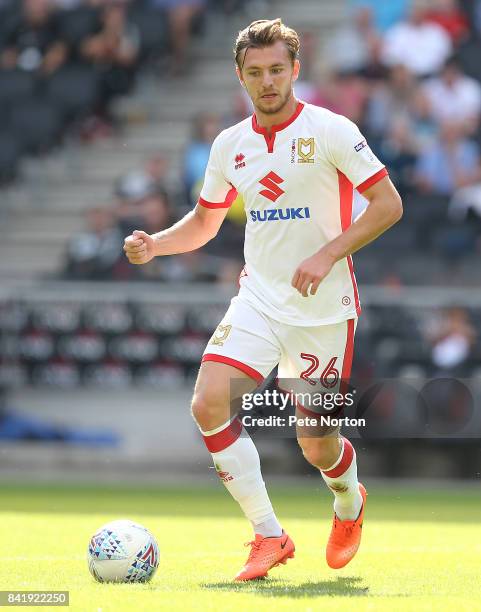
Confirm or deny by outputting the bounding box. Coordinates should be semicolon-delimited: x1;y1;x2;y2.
202;422;282;537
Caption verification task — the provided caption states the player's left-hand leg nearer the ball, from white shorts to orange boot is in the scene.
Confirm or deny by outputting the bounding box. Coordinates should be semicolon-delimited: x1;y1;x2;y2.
192;300;294;580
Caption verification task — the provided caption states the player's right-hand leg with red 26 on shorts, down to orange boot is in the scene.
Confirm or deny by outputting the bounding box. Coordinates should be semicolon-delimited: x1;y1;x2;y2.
279;319;365;567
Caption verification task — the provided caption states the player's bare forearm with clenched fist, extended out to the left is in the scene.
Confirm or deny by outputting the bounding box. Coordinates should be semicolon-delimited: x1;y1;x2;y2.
124;204;228;264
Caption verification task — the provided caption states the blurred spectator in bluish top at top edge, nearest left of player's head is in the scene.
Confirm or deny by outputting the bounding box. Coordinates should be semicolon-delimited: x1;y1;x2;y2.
149;0;206;76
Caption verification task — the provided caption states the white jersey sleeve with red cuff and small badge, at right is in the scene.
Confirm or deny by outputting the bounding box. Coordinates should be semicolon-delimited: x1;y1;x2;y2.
327;115;388;193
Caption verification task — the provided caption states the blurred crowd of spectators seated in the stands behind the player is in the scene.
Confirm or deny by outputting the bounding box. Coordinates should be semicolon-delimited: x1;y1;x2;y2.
0;0;481;280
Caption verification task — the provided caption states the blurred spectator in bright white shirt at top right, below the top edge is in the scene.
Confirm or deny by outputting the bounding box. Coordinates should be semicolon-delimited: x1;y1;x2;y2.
382;0;452;76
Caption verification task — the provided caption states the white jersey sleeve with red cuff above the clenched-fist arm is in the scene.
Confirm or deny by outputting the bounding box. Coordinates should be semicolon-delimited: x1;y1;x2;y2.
199;135;237;208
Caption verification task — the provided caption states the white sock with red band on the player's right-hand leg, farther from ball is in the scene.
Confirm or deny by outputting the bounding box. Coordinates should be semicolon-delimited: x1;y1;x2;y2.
321;437;362;521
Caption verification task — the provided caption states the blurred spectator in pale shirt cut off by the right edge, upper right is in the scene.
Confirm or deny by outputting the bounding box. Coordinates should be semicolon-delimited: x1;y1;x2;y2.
424;58;481;133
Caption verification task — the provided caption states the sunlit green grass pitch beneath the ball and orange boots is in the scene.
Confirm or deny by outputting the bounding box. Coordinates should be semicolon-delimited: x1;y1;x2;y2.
0;479;481;612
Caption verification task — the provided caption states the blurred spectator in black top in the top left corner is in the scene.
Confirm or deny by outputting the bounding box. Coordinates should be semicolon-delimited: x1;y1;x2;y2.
0;0;68;75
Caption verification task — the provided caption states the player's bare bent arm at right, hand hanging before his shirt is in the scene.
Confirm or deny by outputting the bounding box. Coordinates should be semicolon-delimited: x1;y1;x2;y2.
292;176;403;297
